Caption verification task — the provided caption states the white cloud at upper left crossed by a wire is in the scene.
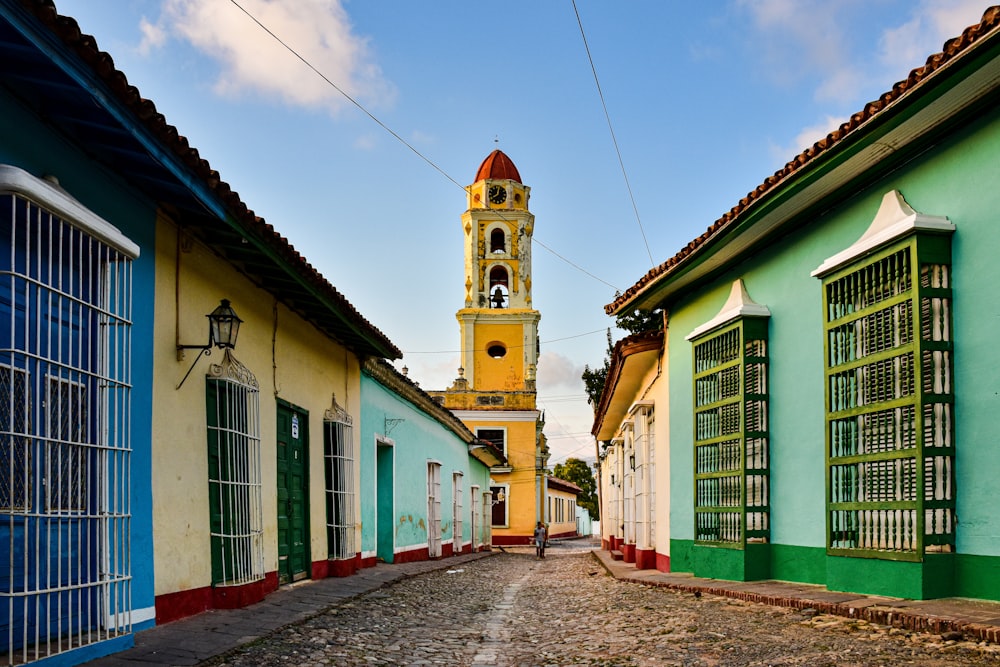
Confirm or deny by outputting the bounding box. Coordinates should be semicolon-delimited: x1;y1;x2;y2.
150;0;395;111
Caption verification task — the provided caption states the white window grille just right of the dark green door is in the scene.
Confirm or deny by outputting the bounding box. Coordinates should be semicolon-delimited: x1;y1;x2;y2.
323;410;357;560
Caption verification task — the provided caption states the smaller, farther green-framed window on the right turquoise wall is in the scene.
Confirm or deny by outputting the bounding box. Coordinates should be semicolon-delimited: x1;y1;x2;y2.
691;317;770;549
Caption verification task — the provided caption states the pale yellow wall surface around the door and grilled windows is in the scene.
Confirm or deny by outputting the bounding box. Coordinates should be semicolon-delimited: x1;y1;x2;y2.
152;218;361;595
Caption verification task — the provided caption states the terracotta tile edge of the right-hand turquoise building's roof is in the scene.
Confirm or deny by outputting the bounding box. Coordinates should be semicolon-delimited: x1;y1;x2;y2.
604;6;1000;315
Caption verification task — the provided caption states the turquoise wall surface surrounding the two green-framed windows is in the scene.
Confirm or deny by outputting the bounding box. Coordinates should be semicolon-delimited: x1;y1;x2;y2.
669;98;1000;599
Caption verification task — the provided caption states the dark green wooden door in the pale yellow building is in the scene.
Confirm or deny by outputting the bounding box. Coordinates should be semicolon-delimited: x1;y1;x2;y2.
278;403;310;583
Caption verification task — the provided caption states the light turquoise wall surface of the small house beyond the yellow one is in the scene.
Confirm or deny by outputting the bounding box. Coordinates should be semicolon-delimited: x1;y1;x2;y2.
359;373;489;554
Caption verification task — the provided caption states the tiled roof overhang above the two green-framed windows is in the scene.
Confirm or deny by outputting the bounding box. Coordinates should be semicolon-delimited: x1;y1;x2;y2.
605;7;1000;316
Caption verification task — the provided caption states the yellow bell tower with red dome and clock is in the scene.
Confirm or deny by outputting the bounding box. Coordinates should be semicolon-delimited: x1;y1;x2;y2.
428;150;548;544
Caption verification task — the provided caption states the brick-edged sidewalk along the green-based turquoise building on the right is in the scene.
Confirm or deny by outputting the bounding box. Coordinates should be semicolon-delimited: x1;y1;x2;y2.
592;550;1000;643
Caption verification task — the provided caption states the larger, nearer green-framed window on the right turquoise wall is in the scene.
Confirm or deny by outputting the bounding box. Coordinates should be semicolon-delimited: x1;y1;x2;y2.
823;233;956;561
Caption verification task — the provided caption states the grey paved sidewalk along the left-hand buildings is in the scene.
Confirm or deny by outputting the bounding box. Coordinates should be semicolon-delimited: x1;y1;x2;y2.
84;551;493;667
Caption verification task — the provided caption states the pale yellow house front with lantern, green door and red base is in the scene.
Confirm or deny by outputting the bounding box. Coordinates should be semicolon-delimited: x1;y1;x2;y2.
151;206;396;623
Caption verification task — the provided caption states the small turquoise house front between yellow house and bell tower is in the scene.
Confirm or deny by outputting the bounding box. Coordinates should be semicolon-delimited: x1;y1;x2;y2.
358;360;504;566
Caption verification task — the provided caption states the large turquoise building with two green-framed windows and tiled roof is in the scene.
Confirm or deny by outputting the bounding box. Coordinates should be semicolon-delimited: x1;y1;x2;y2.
607;8;1000;600
